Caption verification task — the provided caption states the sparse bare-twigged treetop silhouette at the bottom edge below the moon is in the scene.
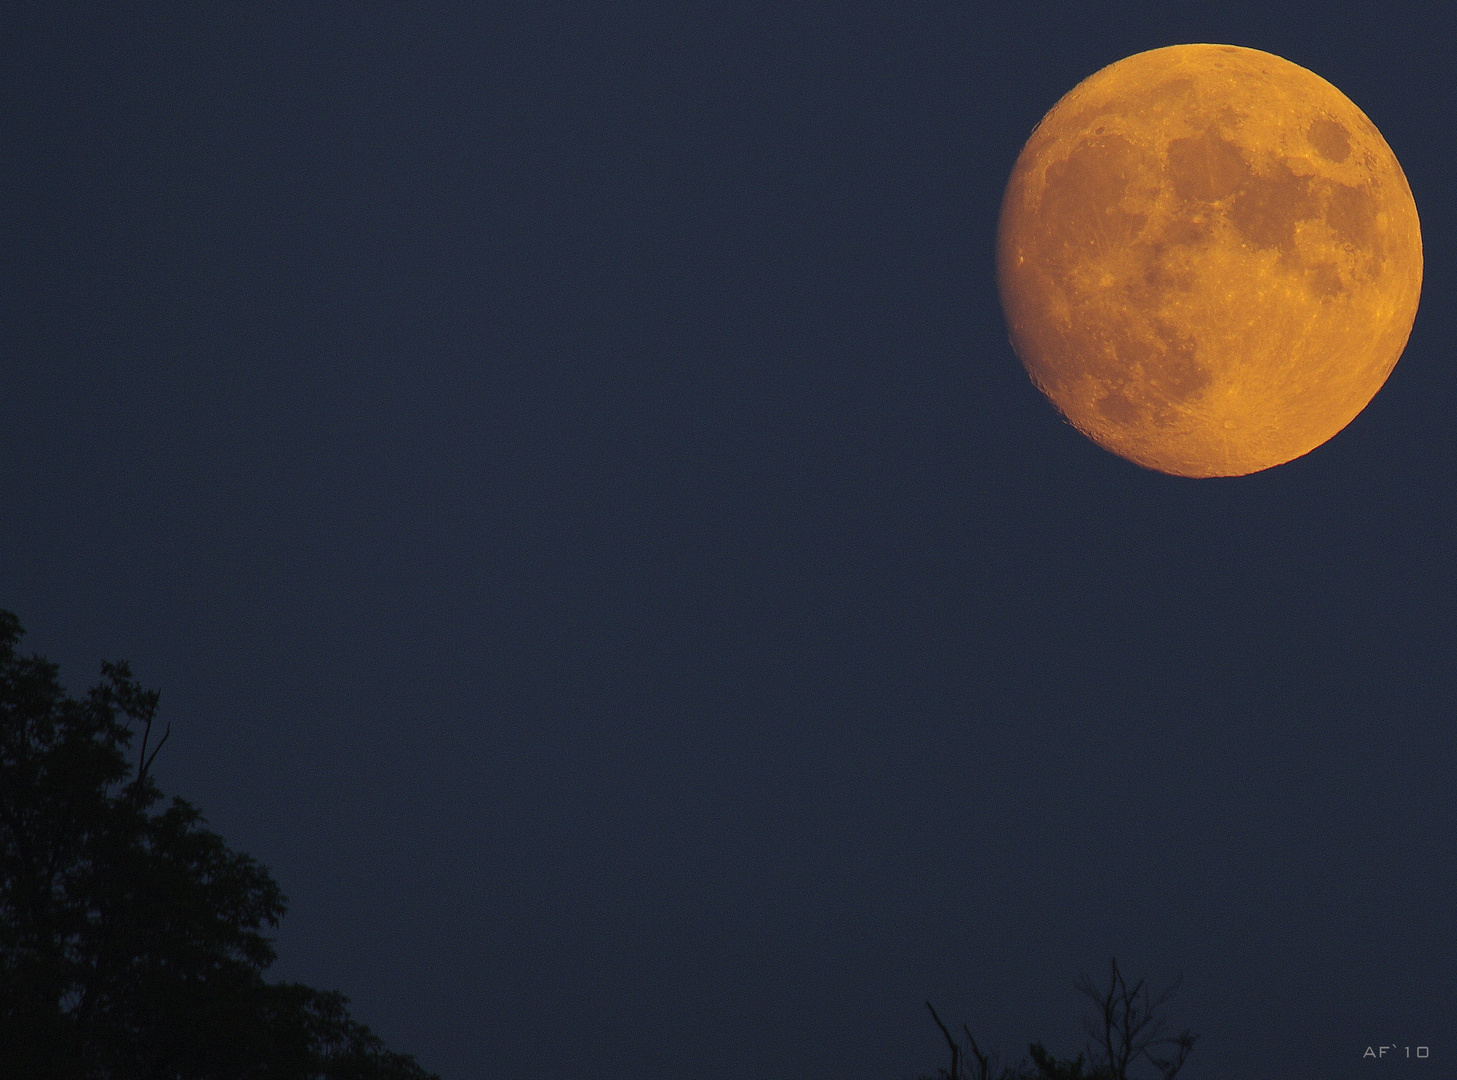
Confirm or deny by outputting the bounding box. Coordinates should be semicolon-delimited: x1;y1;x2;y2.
919;959;1199;1080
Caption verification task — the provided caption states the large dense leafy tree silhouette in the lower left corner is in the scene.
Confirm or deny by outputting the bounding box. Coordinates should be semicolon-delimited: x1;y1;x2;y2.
0;611;439;1080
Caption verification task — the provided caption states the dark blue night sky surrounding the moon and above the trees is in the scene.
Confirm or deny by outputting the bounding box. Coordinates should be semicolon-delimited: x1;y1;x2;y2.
0;0;1457;1080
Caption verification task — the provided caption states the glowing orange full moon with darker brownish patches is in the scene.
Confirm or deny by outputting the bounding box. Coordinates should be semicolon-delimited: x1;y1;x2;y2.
997;45;1422;477
